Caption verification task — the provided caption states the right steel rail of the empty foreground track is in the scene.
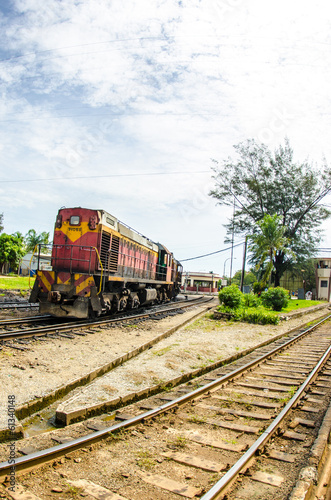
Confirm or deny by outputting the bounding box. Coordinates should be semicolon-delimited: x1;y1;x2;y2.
200;346;331;500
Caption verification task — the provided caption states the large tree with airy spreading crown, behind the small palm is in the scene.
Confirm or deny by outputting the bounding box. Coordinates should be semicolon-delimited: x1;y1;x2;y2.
210;139;331;286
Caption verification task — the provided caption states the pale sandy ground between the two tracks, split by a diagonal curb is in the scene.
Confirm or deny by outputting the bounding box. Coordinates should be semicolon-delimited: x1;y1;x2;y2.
0;298;330;428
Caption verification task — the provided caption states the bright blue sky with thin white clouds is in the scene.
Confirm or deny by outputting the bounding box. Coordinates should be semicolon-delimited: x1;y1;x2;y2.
0;0;331;275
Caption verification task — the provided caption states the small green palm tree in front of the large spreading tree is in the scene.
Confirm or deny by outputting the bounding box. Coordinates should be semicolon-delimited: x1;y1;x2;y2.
248;214;294;283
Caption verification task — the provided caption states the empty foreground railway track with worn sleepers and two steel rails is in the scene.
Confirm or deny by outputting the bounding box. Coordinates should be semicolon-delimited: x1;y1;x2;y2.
0;316;331;500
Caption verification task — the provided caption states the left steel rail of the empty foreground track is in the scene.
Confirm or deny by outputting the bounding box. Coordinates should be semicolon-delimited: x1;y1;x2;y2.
0;314;331;478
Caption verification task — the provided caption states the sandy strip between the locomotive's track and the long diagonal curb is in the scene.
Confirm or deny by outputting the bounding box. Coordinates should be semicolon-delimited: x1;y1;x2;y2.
0;305;210;440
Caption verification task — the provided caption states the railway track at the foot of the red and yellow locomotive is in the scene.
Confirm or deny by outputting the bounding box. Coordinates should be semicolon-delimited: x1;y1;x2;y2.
0;297;213;343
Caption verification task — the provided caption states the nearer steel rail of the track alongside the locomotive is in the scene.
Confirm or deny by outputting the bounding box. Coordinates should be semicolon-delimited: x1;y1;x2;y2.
0;297;213;340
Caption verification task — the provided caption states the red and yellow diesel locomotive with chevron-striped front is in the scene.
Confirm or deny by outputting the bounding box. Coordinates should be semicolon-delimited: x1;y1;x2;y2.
30;207;182;318
